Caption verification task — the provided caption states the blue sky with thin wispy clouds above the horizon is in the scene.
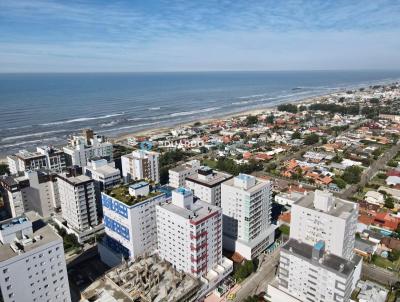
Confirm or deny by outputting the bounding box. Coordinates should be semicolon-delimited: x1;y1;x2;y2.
0;0;400;72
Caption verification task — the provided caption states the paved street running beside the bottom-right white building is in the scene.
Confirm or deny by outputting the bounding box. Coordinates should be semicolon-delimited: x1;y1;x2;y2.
234;248;280;301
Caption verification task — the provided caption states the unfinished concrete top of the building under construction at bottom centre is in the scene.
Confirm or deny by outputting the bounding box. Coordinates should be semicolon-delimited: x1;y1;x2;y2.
82;255;201;302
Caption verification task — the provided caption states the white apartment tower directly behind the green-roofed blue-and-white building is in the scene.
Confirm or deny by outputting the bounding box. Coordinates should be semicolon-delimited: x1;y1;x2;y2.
121;150;160;183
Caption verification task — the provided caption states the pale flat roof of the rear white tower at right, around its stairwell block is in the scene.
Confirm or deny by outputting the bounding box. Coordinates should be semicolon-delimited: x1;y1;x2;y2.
293;192;355;219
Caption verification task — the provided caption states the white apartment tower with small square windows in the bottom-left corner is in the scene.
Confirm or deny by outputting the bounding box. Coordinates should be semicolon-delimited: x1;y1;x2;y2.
0;212;71;302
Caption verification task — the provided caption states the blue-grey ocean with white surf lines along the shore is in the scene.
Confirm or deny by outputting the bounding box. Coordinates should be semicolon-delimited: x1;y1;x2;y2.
0;71;400;155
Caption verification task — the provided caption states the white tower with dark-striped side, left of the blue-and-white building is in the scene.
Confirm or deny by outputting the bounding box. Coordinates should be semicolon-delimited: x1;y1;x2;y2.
57;172;99;242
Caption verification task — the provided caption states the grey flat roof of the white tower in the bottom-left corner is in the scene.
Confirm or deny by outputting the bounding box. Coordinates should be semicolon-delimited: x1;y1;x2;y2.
0;212;62;262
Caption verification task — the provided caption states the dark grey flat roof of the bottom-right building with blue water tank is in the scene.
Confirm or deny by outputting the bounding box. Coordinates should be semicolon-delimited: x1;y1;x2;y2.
282;239;361;277
